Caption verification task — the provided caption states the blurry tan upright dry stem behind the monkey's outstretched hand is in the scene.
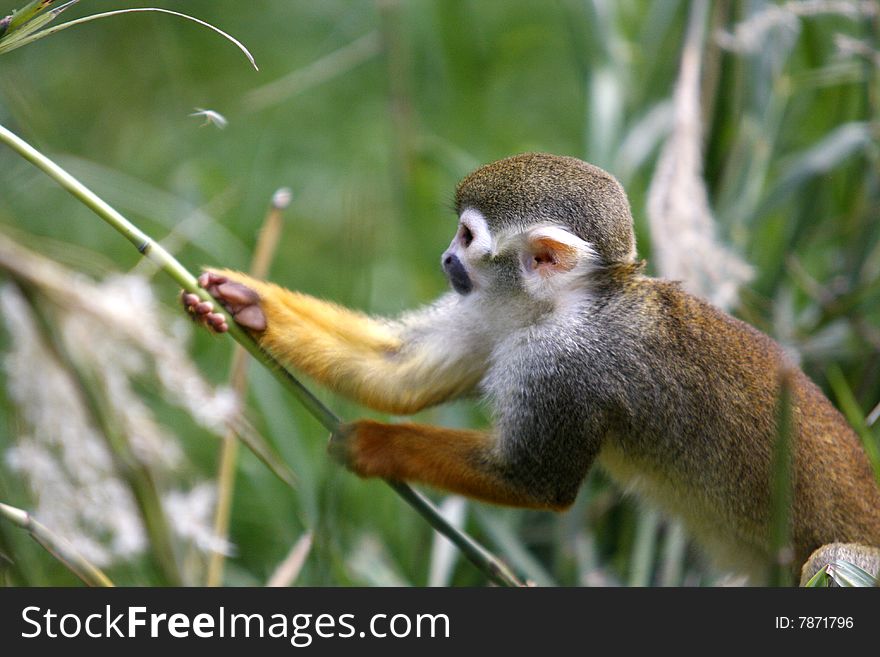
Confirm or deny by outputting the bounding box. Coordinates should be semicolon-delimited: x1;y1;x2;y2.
205;189;290;586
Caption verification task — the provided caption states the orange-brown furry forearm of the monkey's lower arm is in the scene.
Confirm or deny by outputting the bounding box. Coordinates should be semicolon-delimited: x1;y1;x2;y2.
329;420;573;511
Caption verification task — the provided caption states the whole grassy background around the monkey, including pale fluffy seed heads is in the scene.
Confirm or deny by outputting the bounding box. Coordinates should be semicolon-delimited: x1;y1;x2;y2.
0;0;880;585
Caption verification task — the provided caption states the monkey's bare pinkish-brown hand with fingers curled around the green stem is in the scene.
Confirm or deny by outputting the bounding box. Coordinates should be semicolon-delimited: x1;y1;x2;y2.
180;272;266;333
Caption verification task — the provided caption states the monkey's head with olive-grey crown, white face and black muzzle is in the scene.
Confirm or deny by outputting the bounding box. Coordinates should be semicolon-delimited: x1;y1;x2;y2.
441;153;635;298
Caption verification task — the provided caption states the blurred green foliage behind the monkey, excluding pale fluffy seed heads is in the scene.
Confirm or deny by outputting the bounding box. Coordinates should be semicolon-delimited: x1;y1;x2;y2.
0;0;880;585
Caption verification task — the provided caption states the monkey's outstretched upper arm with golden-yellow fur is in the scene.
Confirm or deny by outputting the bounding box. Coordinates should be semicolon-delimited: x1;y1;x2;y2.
208;270;486;414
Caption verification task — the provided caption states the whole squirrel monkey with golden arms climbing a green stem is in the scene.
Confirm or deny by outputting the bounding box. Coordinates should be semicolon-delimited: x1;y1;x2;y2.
183;153;880;577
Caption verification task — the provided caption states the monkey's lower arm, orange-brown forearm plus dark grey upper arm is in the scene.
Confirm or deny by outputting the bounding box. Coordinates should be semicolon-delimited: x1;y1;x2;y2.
330;366;604;511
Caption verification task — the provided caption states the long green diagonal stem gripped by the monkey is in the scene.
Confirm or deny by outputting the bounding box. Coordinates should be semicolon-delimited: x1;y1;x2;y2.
0;125;524;586
